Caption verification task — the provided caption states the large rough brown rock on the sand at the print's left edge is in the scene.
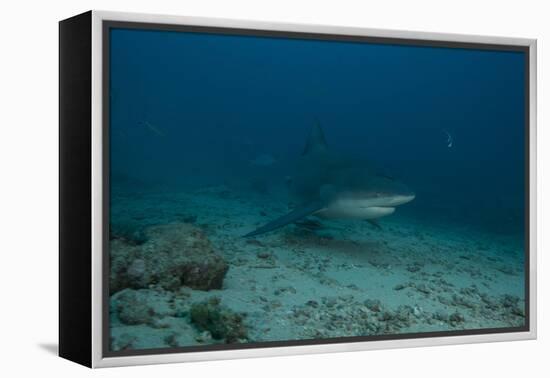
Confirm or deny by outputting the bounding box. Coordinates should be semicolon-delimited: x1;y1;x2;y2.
110;223;228;294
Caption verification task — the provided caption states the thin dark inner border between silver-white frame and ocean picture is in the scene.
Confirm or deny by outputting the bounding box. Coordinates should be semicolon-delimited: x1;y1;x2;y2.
101;20;531;358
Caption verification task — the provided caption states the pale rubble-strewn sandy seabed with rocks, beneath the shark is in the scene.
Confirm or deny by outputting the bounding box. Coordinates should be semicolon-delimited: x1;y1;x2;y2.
109;186;525;351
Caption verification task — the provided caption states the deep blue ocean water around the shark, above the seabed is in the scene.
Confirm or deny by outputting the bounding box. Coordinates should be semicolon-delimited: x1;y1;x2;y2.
109;29;526;347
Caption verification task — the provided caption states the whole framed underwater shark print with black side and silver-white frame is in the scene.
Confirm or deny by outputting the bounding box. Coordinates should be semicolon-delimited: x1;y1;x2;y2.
59;11;536;367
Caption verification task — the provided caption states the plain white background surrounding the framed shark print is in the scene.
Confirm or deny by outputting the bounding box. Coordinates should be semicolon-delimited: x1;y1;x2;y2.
0;0;550;378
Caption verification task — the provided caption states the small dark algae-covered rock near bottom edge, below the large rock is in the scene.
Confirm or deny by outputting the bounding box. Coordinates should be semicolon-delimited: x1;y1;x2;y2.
190;297;248;343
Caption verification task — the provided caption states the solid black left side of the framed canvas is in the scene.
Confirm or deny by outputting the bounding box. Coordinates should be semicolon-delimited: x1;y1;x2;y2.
58;11;93;367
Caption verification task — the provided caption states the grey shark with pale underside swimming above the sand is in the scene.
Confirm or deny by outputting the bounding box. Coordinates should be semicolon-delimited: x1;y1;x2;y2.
244;122;415;237
